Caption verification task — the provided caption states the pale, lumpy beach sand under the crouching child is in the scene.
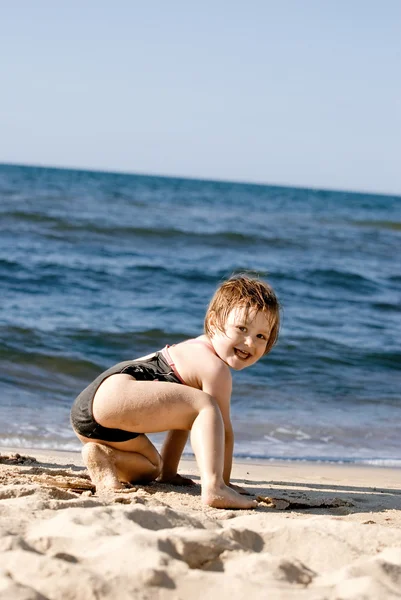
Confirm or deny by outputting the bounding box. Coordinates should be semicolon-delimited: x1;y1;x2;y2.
0;448;401;600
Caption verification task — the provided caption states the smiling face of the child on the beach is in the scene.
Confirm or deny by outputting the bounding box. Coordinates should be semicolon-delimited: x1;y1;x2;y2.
210;307;271;371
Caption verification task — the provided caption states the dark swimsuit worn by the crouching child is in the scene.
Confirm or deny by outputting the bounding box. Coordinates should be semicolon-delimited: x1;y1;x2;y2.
71;348;185;442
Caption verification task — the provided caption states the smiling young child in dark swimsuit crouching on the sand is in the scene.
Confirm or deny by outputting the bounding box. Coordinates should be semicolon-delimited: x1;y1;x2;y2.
71;275;280;508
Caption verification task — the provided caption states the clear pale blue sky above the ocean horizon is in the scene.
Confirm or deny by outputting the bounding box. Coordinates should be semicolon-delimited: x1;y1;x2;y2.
0;0;401;194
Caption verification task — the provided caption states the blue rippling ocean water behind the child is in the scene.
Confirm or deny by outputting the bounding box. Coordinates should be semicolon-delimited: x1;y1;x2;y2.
0;165;401;466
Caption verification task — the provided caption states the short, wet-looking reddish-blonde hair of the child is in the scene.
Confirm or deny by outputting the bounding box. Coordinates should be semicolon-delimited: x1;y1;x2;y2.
205;274;280;354
